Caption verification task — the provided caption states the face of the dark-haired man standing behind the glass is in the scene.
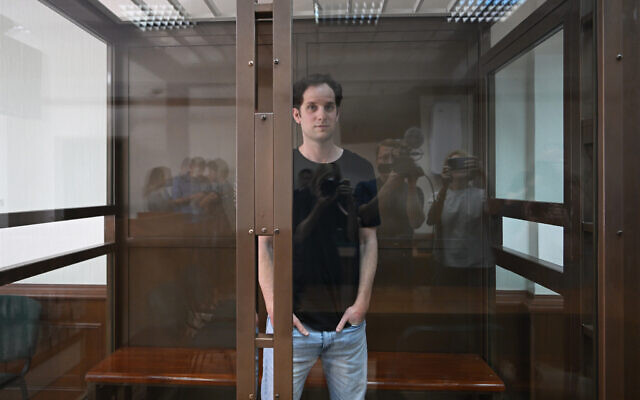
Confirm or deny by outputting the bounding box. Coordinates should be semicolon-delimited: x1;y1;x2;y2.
293;83;338;142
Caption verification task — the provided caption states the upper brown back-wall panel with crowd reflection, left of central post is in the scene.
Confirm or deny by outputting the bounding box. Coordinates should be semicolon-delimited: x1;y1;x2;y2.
129;44;236;240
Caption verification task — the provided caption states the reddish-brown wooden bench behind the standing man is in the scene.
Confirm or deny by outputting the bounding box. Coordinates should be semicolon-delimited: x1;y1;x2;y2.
85;347;505;398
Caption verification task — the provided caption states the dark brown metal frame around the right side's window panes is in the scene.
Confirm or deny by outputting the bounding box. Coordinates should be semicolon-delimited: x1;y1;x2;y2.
480;0;579;293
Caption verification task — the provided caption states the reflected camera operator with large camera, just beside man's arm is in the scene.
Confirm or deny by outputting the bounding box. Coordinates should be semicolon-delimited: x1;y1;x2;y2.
360;139;425;240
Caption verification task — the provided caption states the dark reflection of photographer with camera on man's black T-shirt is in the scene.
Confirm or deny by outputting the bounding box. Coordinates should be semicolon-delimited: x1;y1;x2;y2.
294;163;358;242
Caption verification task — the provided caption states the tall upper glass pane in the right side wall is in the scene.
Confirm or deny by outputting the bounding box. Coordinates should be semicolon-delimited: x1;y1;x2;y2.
492;30;564;203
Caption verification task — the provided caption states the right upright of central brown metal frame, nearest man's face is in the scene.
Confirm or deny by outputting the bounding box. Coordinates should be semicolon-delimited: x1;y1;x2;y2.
273;0;293;399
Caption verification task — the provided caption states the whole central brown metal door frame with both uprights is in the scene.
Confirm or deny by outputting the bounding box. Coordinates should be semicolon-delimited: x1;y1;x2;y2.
236;0;293;399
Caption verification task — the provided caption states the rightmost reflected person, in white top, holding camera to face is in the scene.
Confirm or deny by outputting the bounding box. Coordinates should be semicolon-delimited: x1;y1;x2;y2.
427;150;488;268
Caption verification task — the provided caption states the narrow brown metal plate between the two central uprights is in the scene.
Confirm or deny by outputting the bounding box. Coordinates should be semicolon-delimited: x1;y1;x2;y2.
254;113;274;235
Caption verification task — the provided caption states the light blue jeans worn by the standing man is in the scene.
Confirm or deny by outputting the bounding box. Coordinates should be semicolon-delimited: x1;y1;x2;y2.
261;319;367;400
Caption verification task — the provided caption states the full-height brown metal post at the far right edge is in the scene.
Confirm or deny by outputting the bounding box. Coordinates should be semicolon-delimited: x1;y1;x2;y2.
596;0;625;399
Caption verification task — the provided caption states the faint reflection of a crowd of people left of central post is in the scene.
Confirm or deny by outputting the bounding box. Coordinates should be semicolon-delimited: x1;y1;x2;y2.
144;157;235;233
